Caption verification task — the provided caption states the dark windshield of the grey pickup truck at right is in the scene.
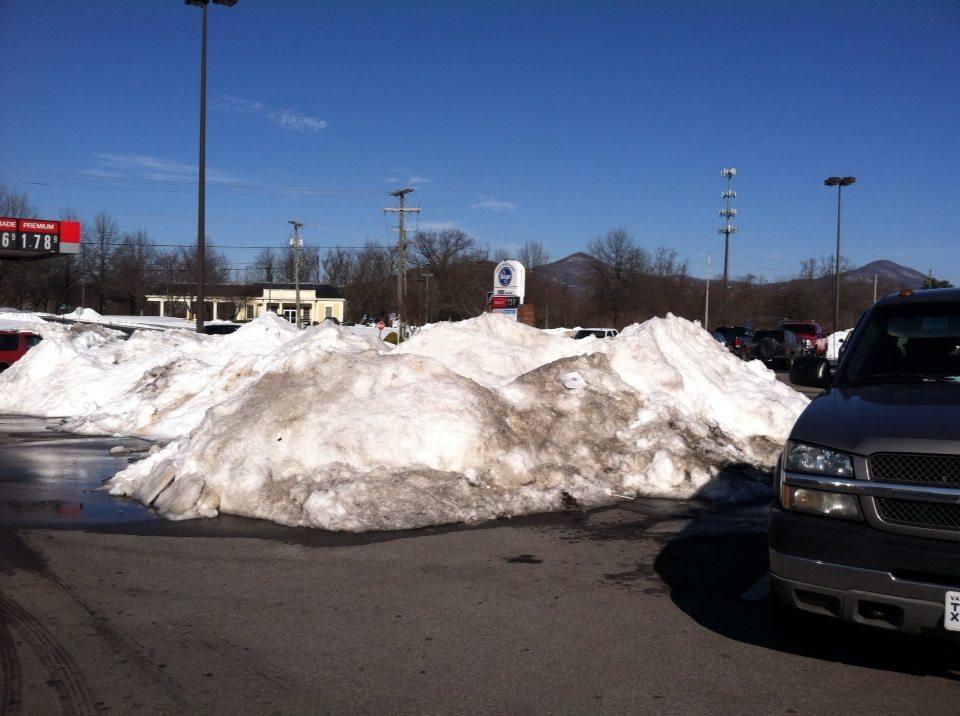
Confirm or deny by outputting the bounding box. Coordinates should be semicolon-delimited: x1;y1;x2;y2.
841;303;960;385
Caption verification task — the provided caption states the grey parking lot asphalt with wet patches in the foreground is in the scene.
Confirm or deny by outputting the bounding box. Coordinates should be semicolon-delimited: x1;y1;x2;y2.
0;418;960;713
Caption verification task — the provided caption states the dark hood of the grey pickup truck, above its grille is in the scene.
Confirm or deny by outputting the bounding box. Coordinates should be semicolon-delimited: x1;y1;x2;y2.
790;383;960;455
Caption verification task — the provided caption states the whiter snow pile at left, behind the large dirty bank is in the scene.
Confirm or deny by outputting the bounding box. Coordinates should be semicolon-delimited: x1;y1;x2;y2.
0;314;369;439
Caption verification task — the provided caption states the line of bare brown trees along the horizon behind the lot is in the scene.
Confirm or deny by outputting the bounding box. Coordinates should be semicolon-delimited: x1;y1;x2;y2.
0;185;946;328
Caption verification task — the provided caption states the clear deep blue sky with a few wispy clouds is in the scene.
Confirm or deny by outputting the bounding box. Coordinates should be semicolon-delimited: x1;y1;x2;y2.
0;0;960;284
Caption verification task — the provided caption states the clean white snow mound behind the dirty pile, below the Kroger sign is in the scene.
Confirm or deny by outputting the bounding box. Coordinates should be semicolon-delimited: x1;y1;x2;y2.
397;313;596;388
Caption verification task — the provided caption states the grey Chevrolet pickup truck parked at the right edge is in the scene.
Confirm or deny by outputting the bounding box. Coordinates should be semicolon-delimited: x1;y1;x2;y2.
769;289;960;638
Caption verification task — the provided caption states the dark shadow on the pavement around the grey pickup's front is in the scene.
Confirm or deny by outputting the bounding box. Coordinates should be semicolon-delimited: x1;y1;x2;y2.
654;521;960;681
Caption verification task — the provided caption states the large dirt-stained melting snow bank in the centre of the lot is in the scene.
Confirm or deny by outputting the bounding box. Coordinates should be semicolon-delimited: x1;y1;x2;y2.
99;315;807;531
